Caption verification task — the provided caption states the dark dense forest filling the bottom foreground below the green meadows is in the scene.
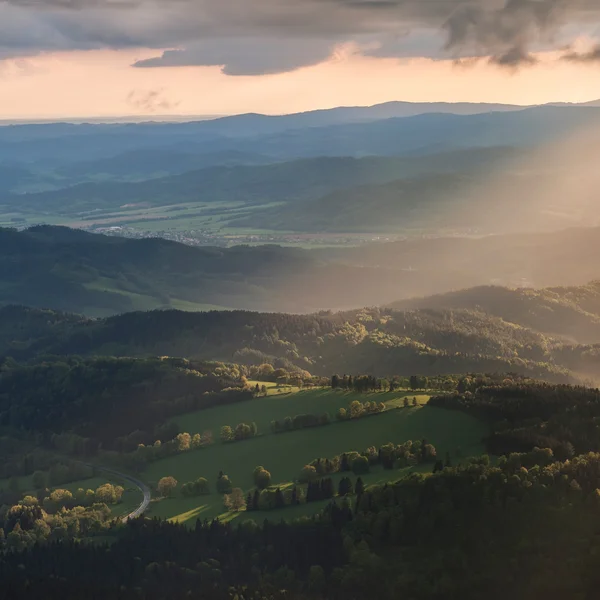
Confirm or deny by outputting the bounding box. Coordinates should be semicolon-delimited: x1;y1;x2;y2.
5;428;600;600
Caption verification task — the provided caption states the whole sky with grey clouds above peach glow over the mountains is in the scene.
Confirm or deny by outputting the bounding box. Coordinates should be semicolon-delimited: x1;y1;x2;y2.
0;0;600;119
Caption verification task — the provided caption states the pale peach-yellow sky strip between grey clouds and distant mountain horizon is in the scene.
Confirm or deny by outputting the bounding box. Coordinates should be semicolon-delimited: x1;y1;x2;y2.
0;46;600;119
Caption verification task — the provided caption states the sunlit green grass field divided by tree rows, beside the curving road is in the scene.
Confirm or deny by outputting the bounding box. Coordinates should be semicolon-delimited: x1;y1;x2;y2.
141;390;487;523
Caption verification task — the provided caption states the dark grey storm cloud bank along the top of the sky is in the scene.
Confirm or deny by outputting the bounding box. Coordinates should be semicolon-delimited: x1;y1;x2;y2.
0;0;600;75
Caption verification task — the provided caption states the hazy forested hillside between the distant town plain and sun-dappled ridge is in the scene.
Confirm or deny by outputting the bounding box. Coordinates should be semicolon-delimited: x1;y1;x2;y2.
5;226;600;316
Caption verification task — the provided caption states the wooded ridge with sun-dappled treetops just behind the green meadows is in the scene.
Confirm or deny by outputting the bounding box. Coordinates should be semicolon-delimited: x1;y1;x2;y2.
0;306;598;383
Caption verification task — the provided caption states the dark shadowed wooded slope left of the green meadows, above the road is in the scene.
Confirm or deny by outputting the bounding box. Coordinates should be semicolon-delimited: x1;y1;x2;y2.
0;357;252;456
